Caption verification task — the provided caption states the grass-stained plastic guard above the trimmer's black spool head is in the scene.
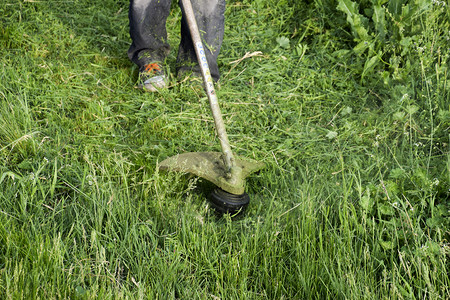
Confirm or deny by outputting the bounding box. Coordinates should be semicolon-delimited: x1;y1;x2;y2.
159;152;264;195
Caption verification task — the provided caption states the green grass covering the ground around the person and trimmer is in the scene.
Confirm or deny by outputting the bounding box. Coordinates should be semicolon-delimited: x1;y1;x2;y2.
0;0;450;299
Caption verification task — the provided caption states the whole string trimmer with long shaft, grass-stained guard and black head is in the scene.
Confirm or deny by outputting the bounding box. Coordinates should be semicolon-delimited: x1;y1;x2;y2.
159;0;264;213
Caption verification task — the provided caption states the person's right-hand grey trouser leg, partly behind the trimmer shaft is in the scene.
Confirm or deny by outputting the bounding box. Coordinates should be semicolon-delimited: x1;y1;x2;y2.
177;0;225;81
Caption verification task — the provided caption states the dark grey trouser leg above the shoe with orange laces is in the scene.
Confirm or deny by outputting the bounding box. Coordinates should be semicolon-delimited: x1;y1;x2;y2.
128;0;172;69
